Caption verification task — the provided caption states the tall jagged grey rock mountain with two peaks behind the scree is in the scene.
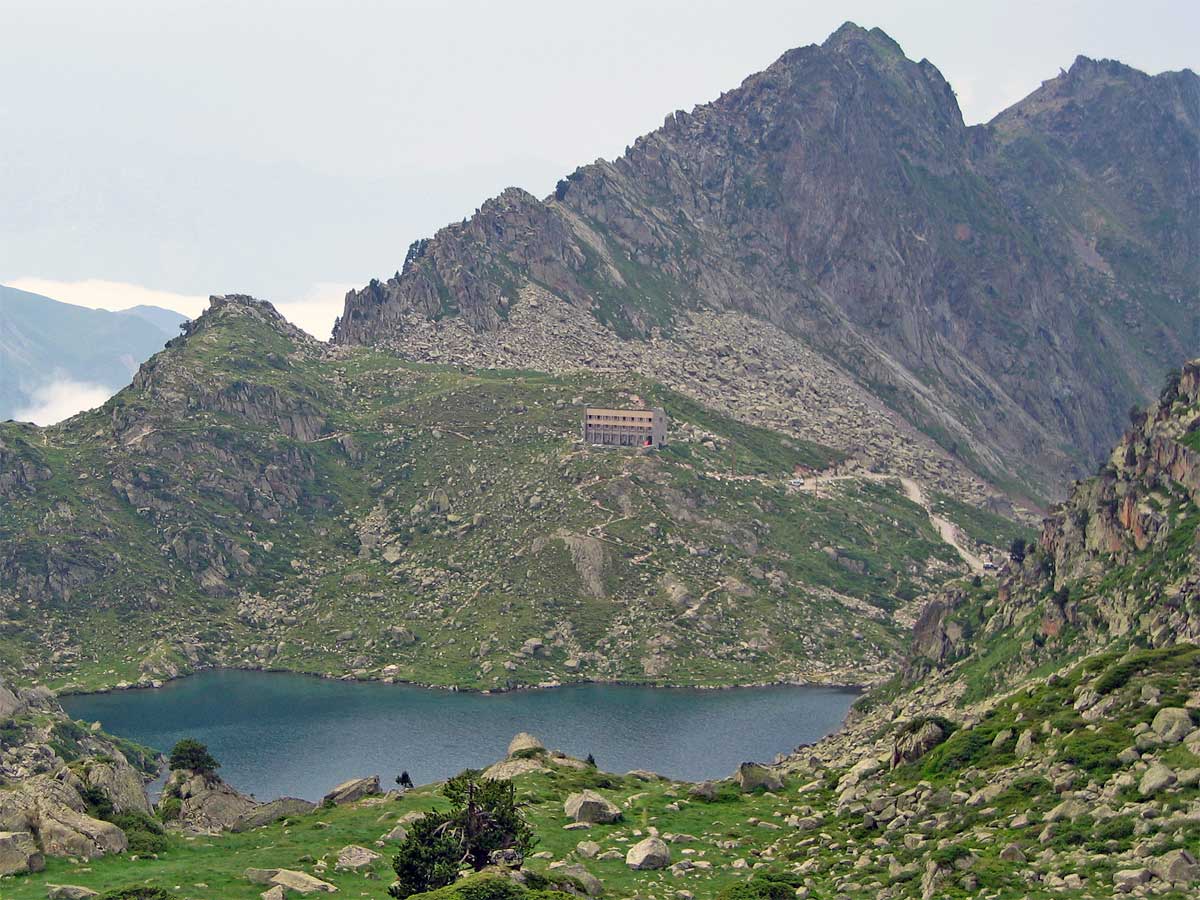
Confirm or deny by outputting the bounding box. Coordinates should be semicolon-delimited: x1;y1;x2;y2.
335;25;1200;493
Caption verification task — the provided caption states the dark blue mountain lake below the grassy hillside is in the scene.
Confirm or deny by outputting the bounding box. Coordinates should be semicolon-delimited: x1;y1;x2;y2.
62;671;857;799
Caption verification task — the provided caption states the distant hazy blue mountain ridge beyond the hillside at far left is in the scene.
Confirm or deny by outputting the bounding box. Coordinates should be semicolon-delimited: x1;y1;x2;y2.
0;284;186;420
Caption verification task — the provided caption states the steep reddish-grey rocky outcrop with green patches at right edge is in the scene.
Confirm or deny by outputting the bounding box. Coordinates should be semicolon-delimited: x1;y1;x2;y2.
908;360;1200;700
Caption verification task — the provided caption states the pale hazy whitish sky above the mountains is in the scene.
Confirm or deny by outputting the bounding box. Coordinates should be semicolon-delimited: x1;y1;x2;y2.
0;0;1200;337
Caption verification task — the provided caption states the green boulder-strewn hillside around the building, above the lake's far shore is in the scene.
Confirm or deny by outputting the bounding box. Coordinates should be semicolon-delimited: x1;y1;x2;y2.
0;307;984;689
